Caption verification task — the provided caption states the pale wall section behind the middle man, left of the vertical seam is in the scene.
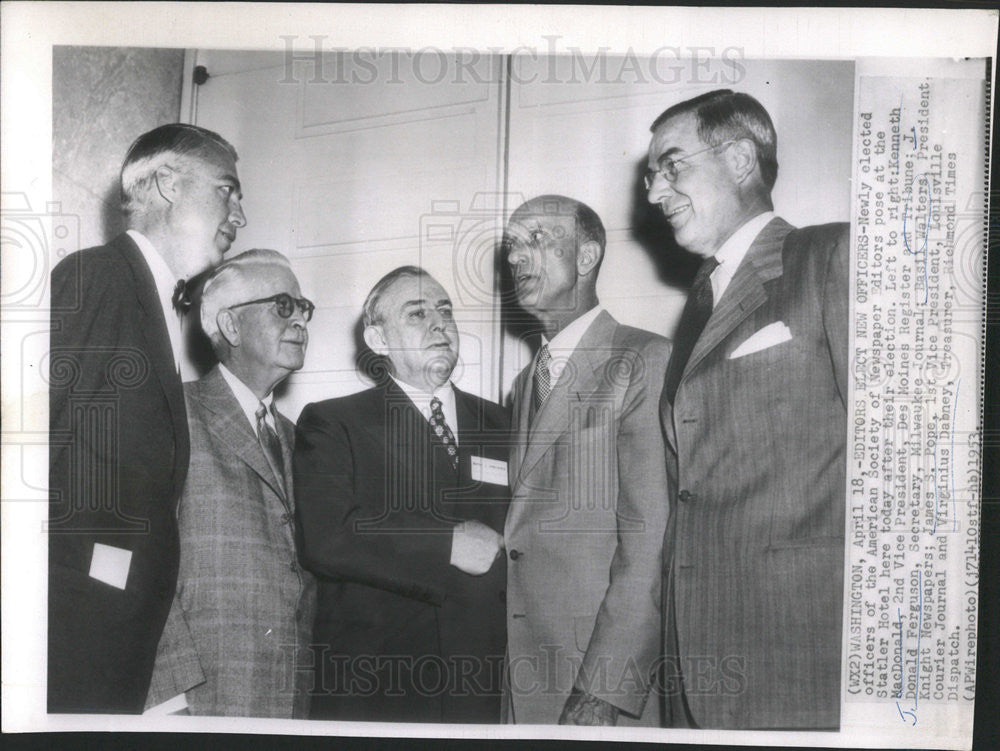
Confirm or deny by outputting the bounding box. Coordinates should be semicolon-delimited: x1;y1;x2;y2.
192;50;503;419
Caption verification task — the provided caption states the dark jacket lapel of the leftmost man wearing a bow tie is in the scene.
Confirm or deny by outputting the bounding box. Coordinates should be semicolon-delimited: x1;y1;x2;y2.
113;234;191;496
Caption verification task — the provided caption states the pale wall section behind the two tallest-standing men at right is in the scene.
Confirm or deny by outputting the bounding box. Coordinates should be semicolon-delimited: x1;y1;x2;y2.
502;55;854;396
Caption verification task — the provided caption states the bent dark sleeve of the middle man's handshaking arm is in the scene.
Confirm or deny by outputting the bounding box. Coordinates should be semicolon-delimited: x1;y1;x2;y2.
294;405;452;605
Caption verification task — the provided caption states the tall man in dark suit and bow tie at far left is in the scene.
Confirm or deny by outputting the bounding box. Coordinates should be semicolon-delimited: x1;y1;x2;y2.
48;123;246;713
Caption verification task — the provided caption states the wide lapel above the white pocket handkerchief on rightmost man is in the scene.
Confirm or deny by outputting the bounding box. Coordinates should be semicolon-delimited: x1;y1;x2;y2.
681;217;793;383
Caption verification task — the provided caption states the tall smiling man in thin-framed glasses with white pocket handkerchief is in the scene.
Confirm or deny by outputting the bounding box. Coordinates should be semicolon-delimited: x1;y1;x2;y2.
646;90;848;730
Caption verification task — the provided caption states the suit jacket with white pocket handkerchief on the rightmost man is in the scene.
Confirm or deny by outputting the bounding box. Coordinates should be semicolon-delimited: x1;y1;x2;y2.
661;219;849;728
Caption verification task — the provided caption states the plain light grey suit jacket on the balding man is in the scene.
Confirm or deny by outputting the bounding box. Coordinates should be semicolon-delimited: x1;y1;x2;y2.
504;312;670;725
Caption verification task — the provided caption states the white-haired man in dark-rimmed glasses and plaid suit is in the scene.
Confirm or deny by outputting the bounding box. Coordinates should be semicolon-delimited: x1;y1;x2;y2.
146;250;316;718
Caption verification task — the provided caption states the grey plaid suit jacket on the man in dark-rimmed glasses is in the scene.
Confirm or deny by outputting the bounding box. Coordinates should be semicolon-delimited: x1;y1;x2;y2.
146;368;316;717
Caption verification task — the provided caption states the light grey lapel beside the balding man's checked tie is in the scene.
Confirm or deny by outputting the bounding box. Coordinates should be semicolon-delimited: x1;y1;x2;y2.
517;311;618;479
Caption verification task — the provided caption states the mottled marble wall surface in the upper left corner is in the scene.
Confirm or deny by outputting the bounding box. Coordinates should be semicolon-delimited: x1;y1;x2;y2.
52;47;184;253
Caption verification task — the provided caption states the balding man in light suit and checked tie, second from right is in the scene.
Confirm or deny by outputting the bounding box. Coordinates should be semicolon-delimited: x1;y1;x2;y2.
504;195;670;726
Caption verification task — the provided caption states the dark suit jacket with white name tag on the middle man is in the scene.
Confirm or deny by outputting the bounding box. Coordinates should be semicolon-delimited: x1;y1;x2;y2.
295;382;508;722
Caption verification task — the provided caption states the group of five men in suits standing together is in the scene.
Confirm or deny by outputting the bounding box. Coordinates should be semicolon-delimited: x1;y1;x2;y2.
48;90;848;729
